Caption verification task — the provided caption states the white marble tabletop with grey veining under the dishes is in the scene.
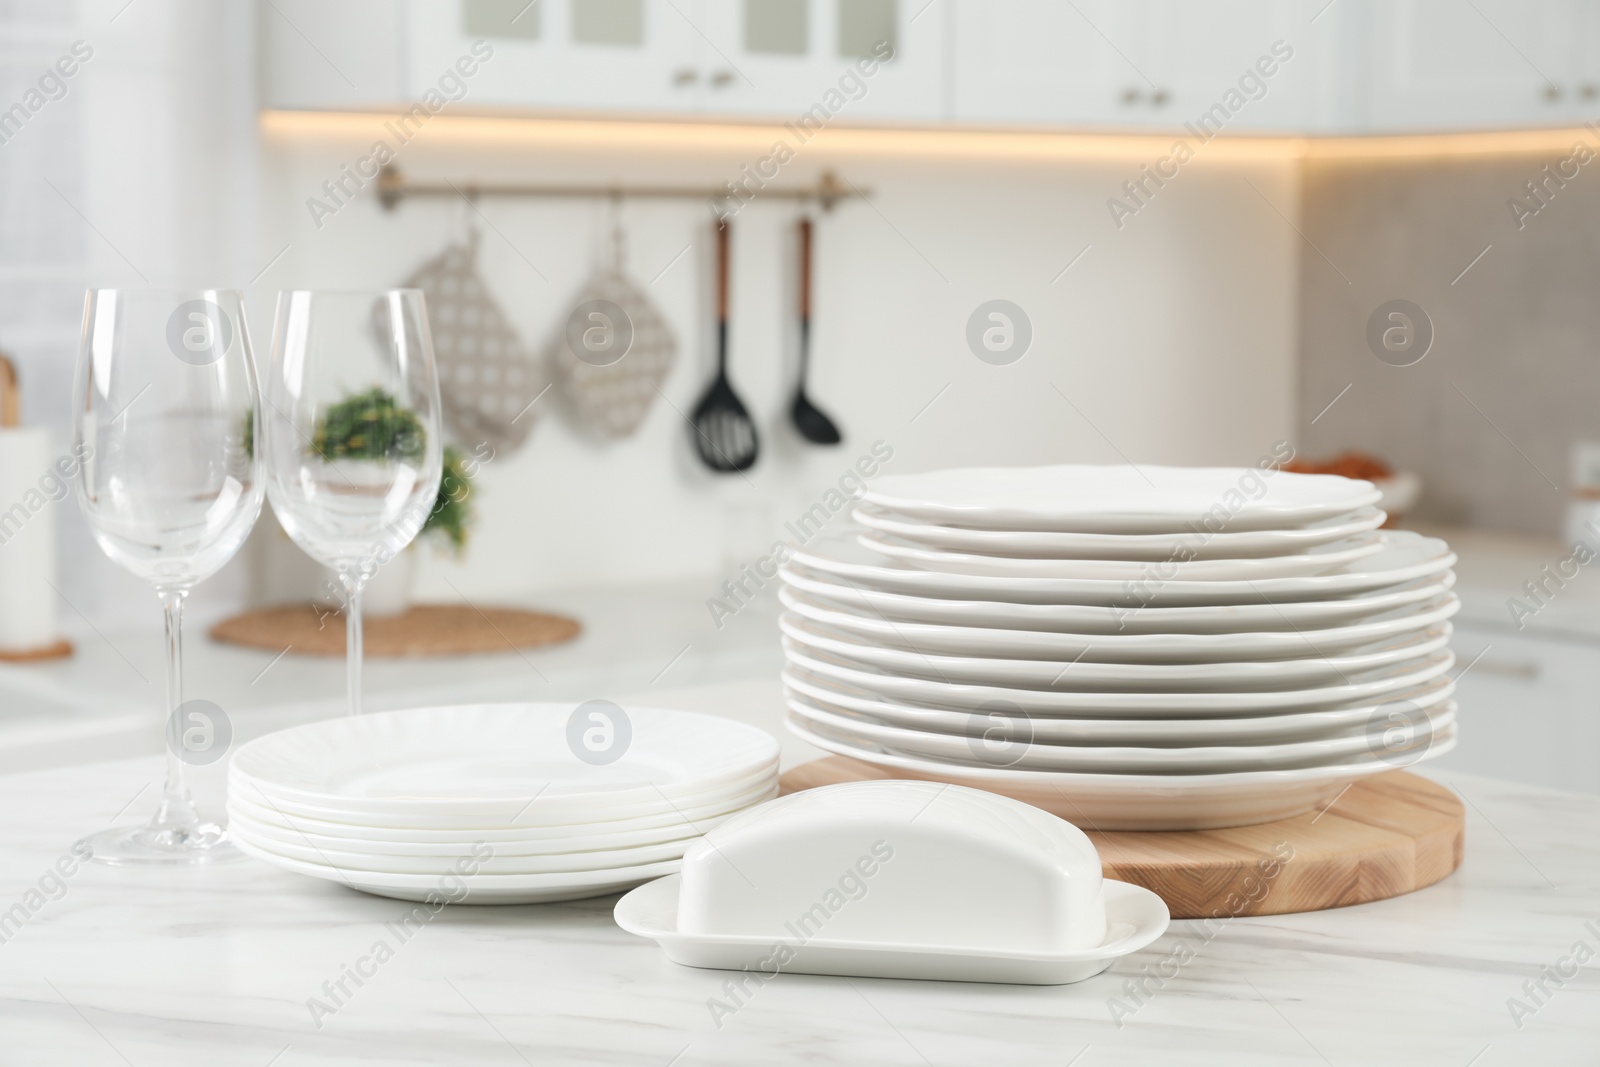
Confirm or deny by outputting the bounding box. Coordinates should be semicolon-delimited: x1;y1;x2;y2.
0;677;1600;1067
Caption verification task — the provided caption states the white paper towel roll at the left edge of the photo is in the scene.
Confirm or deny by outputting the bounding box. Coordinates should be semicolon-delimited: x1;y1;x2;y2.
0;427;60;653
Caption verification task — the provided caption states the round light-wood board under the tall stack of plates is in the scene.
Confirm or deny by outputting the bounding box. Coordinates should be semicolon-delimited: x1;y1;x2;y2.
779;755;1466;918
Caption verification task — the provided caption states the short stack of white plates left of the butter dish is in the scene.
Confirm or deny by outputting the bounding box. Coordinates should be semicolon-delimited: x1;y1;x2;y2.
227;701;778;904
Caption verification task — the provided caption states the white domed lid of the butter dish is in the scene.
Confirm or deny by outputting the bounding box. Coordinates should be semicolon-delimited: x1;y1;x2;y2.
677;781;1106;952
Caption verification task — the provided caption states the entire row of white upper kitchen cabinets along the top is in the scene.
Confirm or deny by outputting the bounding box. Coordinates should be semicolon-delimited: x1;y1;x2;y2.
259;0;1600;134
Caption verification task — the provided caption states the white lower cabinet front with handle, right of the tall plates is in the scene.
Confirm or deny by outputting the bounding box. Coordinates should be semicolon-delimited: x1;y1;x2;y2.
1429;624;1600;793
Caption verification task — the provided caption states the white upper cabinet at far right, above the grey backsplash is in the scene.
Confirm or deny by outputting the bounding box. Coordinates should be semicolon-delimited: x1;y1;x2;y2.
1341;0;1595;131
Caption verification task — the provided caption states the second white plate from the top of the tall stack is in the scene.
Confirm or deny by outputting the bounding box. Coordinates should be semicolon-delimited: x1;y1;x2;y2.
851;506;1386;563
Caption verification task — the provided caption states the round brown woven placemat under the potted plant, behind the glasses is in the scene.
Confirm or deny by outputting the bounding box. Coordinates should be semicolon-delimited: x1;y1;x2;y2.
211;605;582;656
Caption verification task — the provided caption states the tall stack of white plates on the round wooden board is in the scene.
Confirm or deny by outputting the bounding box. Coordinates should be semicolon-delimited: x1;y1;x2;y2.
779;466;1459;830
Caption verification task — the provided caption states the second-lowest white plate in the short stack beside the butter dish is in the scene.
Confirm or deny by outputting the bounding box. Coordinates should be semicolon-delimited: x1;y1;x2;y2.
227;819;696;878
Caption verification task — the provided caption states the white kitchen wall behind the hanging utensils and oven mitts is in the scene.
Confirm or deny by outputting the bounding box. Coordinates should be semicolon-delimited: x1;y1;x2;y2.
256;118;1299;598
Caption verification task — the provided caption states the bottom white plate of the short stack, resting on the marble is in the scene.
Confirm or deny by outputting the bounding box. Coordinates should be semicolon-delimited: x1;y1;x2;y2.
235;840;682;904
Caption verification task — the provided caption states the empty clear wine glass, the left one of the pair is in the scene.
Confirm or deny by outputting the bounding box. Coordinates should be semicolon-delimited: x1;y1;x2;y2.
72;290;261;865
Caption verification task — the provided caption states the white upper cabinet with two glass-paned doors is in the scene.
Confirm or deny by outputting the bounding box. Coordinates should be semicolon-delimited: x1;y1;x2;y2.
406;0;942;122
